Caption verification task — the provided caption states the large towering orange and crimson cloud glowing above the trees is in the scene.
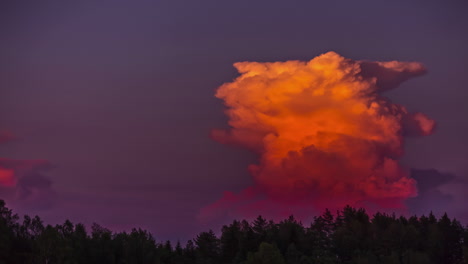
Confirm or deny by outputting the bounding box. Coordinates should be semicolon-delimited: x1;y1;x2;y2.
202;52;435;221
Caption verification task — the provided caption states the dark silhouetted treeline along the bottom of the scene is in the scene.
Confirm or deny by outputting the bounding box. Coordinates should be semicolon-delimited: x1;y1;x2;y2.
0;200;468;264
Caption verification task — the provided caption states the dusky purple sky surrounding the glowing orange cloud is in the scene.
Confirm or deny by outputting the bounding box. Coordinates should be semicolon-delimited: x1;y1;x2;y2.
0;0;468;240
